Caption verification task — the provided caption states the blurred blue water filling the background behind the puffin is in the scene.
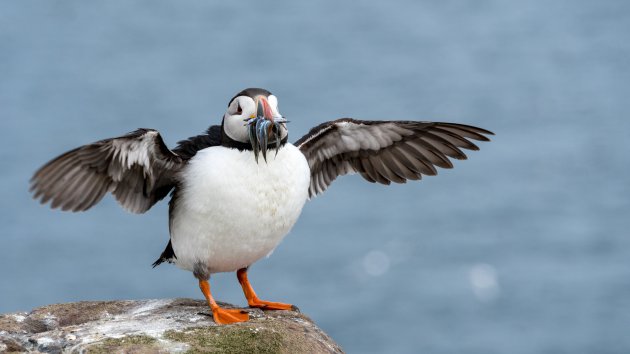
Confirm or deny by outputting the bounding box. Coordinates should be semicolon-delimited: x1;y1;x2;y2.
0;0;630;354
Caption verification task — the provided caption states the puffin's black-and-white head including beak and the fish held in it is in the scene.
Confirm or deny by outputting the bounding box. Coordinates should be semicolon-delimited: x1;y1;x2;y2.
223;88;288;161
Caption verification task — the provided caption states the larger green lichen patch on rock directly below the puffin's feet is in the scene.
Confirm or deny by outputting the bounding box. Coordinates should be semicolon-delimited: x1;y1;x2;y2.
164;324;285;354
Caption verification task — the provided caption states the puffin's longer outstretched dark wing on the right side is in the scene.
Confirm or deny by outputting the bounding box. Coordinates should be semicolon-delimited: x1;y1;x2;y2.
295;118;493;197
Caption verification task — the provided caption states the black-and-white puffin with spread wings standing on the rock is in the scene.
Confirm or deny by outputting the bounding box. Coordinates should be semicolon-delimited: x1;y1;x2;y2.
30;88;493;324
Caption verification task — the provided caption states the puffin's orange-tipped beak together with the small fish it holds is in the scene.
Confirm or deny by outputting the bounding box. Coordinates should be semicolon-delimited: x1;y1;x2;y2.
245;96;287;162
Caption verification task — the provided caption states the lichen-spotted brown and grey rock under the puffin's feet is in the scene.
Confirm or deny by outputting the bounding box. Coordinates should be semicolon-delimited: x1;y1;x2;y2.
0;299;343;353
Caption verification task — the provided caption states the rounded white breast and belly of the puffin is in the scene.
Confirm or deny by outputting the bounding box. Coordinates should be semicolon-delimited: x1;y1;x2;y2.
170;144;310;273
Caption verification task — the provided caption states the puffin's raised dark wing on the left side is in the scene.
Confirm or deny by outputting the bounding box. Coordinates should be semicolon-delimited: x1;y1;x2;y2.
31;129;184;213
